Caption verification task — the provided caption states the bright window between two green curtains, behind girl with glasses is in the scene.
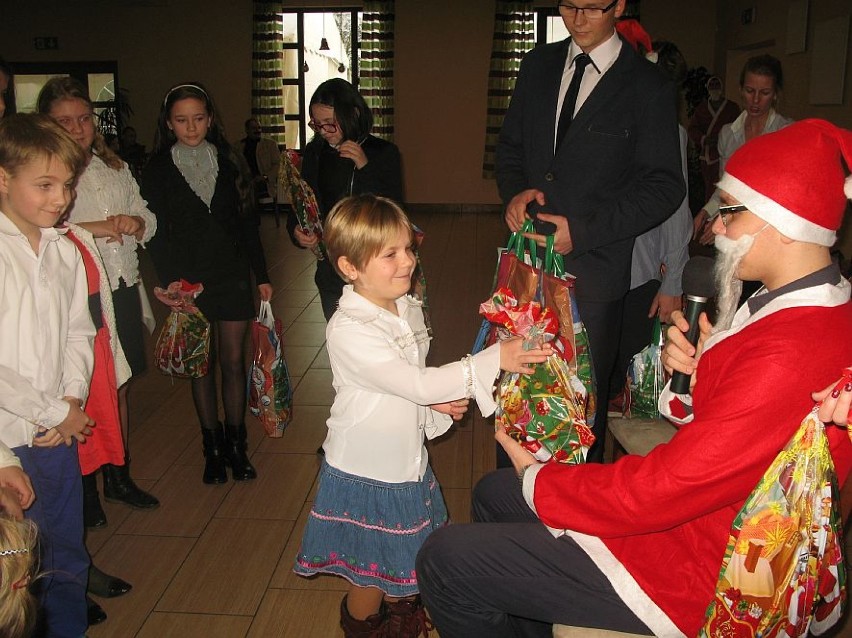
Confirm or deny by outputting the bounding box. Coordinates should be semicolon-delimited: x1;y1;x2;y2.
281;8;362;148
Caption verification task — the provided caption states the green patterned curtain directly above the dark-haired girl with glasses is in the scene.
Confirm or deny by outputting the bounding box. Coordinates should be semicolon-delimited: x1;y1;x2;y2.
358;0;395;141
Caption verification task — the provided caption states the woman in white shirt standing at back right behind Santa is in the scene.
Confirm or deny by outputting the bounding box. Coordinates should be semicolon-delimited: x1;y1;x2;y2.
693;55;793;245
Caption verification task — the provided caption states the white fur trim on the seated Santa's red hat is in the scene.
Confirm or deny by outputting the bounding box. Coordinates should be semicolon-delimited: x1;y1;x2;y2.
717;173;836;246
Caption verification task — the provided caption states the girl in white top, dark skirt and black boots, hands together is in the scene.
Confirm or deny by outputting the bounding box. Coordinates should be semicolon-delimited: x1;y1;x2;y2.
38;77;159;527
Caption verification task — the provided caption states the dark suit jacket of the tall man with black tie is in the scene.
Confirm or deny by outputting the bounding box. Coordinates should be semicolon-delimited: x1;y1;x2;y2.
496;38;685;301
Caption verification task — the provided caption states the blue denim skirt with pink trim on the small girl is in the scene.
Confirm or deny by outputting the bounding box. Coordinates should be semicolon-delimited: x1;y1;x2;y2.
293;462;447;597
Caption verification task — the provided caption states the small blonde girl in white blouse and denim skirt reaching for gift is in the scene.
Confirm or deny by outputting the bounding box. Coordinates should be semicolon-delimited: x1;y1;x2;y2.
294;195;549;636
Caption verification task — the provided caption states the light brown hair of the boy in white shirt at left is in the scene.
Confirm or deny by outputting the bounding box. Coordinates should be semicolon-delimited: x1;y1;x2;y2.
0;113;87;179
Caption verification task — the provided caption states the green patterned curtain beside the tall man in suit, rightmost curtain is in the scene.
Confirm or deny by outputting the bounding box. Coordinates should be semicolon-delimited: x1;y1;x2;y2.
482;0;535;179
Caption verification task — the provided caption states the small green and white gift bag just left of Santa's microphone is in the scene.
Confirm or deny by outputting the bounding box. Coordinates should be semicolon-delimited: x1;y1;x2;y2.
623;317;666;419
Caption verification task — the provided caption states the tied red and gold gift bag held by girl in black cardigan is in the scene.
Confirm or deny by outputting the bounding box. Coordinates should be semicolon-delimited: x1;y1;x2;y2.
154;280;210;378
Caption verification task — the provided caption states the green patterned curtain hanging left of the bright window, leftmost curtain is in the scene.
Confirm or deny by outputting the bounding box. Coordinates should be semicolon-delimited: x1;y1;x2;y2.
251;1;284;146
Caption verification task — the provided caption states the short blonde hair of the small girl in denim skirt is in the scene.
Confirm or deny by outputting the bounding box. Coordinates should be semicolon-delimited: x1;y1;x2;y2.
323;195;414;279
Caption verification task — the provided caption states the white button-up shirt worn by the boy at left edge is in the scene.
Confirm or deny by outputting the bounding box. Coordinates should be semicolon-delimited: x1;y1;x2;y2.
0;212;95;448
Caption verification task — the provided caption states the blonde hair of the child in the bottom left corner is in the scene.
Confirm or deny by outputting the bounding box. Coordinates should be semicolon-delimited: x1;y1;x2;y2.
0;514;38;638
